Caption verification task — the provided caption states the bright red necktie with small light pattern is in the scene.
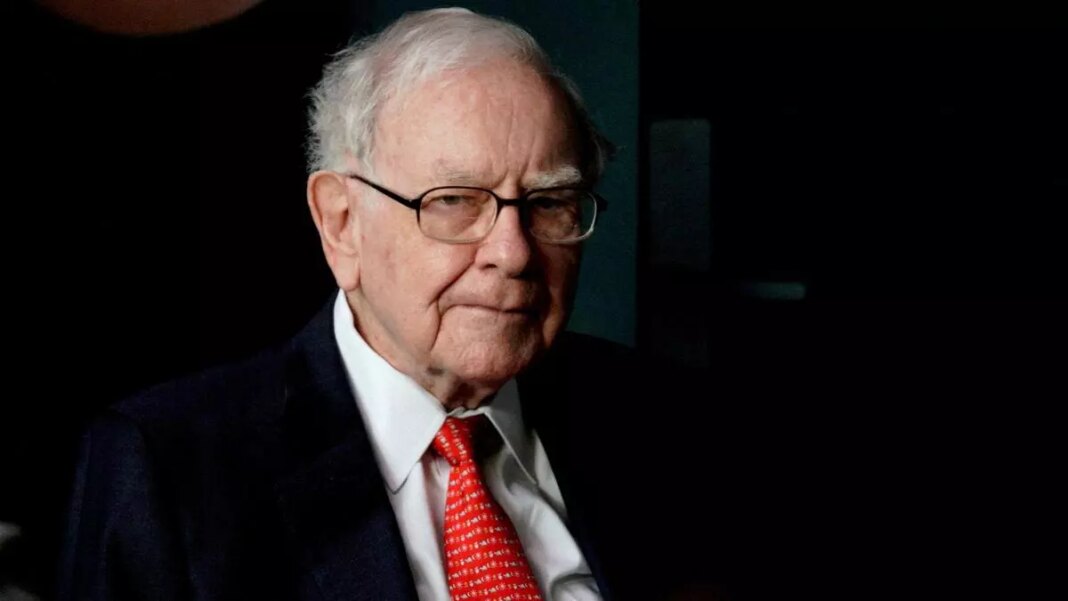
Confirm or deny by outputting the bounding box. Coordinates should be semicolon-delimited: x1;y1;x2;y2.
434;415;541;601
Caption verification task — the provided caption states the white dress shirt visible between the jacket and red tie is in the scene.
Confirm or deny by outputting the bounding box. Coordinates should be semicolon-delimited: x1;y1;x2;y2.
334;292;600;601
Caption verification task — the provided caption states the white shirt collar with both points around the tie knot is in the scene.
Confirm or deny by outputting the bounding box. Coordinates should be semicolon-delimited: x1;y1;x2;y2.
334;290;537;493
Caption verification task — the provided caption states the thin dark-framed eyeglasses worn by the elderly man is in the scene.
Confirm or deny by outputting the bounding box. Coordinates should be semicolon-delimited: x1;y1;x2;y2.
344;173;608;244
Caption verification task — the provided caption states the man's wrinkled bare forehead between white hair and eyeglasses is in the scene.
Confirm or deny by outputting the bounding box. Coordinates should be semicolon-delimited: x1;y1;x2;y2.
375;62;582;188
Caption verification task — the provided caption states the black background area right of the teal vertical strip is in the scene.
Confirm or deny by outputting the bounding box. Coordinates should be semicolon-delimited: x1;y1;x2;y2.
638;2;1068;599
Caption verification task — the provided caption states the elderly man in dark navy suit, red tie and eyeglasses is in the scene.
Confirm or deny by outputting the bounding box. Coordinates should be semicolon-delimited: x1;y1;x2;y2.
62;9;704;601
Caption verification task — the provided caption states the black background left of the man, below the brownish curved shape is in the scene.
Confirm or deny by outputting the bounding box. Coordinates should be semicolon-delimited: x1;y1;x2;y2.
0;0;364;597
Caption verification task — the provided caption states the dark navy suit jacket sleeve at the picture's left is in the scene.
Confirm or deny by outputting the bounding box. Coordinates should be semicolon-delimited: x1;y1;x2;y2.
59;414;193;601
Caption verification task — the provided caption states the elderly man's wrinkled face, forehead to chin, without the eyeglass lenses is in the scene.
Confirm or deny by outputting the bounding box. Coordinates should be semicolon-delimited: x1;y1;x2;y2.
348;62;580;399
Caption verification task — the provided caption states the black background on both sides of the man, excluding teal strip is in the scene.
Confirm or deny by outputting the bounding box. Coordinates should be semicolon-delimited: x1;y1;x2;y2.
0;0;1068;599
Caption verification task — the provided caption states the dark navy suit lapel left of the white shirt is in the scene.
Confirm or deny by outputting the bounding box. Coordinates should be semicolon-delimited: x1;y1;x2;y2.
276;302;417;601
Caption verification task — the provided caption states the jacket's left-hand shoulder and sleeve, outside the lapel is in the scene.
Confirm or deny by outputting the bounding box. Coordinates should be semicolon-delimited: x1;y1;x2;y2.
60;343;311;601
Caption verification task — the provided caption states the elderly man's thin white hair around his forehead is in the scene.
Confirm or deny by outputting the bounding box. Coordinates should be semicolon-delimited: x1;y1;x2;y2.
308;9;614;184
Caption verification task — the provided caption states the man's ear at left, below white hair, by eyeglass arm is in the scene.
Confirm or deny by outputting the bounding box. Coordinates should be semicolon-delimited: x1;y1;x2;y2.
308;171;360;291
